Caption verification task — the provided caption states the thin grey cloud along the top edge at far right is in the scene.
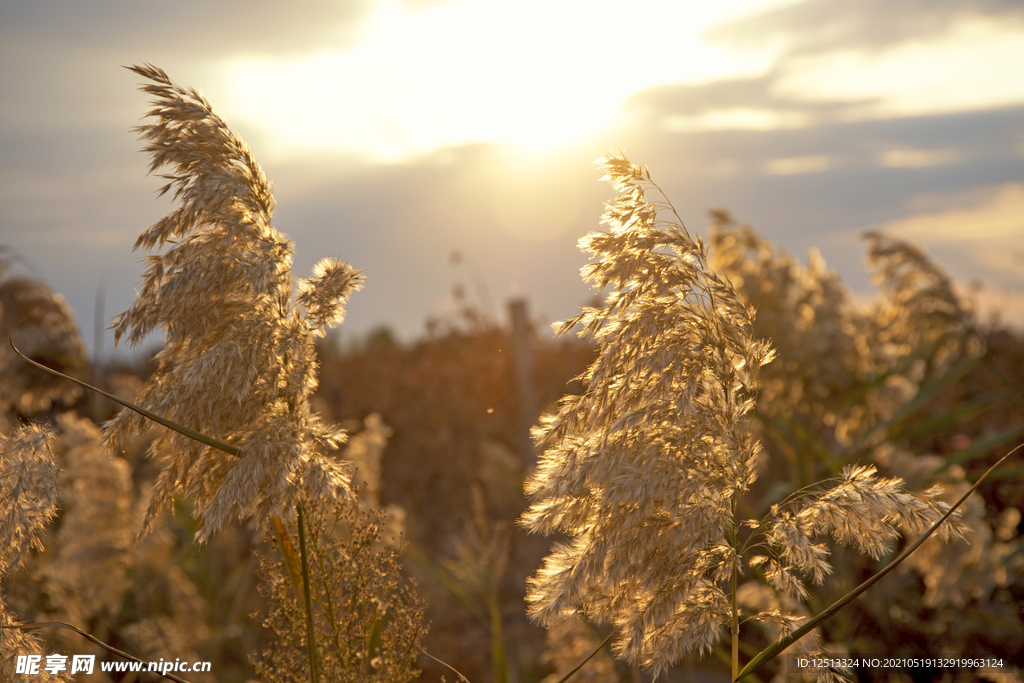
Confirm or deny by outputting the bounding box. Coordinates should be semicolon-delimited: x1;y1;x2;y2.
701;0;1024;55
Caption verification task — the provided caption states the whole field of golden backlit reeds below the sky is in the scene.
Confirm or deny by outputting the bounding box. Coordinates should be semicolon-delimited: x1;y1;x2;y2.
0;66;1024;683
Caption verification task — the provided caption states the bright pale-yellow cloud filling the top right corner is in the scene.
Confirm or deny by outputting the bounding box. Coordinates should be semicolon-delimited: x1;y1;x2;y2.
701;0;1024;123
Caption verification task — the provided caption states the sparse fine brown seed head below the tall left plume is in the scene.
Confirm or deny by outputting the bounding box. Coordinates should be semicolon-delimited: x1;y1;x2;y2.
260;503;427;683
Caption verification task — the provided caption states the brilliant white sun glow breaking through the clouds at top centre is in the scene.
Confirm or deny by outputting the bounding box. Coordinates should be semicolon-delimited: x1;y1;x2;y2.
216;0;780;161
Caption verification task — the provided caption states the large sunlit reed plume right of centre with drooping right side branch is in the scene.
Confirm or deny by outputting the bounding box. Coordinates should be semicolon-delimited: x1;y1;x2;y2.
521;154;964;676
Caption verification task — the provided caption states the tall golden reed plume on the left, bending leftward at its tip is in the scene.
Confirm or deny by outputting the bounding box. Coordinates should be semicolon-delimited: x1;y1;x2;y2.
108;66;362;540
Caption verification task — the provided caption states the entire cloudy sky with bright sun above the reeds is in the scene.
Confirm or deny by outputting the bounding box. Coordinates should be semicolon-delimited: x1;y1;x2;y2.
0;0;1024;362
